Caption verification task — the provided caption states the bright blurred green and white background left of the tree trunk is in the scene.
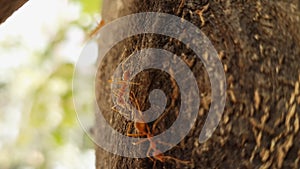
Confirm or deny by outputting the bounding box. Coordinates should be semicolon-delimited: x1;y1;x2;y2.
0;0;101;169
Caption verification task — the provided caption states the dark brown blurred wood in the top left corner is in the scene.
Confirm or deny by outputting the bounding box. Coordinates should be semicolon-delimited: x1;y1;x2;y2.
0;0;28;24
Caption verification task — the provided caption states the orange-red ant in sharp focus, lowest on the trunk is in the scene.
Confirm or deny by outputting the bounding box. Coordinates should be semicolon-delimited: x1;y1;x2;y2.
127;92;190;168
